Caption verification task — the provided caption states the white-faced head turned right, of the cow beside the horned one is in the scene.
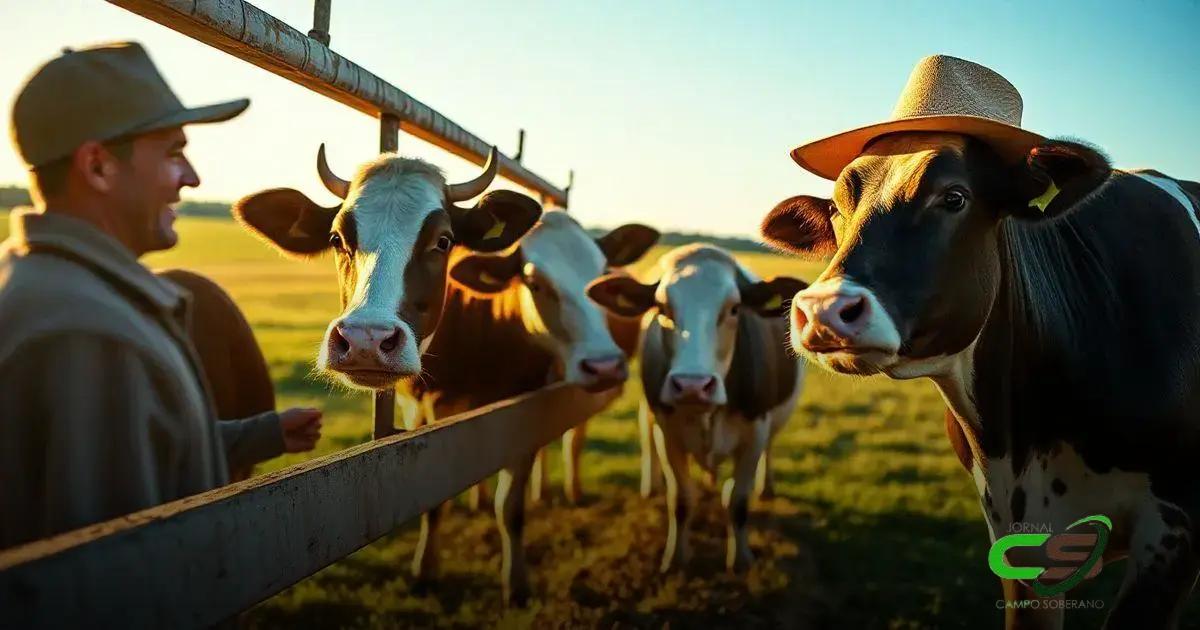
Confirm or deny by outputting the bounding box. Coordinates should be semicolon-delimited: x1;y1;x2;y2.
450;211;659;390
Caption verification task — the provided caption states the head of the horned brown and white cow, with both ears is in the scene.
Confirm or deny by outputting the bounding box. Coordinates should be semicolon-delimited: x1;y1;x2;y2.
233;145;541;389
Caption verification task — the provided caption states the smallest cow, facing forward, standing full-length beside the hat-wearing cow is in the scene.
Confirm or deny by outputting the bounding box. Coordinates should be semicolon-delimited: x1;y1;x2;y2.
588;245;805;572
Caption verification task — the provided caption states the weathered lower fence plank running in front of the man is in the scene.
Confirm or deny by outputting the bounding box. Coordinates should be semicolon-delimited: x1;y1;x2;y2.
0;385;618;628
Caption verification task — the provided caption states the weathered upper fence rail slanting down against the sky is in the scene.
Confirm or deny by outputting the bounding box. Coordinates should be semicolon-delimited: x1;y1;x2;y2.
108;0;568;208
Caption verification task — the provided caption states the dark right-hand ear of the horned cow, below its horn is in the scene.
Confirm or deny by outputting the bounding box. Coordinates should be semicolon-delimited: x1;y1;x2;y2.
450;191;541;253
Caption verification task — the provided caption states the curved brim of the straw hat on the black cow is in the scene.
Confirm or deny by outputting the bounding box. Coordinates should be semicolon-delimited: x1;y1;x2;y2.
792;115;1045;180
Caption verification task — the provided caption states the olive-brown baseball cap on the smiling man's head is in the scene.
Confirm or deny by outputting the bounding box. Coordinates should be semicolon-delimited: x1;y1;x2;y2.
10;42;250;168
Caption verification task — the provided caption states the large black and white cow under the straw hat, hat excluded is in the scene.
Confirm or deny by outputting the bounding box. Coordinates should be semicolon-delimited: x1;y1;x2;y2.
762;132;1200;628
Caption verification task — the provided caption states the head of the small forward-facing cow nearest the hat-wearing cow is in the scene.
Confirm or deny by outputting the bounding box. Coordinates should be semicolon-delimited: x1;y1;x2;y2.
589;246;804;407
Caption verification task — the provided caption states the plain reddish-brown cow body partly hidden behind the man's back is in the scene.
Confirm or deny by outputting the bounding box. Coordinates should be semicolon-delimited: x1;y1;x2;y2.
156;269;275;481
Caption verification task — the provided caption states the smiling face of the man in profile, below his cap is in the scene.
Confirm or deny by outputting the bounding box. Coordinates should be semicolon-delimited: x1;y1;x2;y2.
114;127;200;256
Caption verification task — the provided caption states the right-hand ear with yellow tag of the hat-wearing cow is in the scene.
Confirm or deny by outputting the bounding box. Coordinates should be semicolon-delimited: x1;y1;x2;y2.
1010;140;1112;220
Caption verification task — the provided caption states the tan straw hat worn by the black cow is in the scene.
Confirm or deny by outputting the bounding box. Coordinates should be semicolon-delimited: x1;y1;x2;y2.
792;55;1045;179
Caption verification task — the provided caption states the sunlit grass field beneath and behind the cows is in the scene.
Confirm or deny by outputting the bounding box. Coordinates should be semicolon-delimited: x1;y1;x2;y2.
0;211;1171;628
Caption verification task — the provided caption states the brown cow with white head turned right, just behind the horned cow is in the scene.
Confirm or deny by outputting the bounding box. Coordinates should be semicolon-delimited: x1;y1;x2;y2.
403;210;659;606
